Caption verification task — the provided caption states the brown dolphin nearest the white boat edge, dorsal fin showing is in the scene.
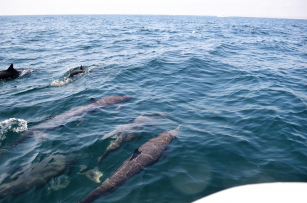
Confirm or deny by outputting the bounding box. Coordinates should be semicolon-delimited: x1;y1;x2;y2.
79;125;180;203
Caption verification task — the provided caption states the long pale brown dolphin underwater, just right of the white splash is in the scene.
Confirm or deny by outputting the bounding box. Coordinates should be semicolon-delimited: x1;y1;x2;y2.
0;95;132;155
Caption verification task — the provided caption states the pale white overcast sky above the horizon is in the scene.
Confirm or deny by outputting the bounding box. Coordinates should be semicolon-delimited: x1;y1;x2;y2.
0;0;307;19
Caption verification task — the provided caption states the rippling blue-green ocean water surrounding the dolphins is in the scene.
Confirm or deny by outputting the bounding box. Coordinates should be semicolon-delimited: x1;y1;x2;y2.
0;15;307;203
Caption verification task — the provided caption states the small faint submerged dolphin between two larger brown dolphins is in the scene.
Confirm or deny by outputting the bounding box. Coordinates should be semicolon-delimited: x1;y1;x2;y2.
97;114;164;167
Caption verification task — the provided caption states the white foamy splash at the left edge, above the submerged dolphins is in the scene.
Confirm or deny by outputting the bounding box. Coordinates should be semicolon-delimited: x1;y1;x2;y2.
0;118;28;140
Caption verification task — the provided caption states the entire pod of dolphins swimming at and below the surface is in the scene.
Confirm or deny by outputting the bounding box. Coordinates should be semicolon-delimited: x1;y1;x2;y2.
0;64;180;203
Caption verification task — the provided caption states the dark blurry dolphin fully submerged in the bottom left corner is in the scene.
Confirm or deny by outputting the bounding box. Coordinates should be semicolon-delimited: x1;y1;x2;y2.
0;155;77;199
